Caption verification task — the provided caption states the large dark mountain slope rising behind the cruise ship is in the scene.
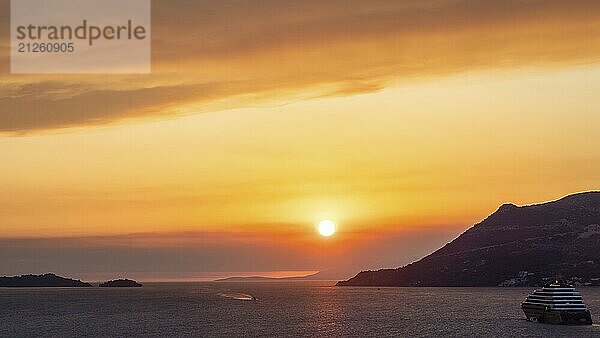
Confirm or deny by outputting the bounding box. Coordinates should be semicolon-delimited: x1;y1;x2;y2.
337;192;600;286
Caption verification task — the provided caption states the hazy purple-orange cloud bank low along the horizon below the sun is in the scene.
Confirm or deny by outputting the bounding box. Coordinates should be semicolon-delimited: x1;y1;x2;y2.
0;227;459;280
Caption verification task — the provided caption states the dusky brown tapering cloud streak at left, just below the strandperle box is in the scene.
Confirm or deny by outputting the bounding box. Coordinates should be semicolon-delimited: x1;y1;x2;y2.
0;82;234;132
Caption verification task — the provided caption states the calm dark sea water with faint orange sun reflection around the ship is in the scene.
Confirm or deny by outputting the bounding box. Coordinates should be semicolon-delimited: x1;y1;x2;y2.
0;282;600;337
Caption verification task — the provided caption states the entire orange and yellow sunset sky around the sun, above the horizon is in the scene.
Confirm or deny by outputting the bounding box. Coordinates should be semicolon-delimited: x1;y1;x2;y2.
0;0;600;280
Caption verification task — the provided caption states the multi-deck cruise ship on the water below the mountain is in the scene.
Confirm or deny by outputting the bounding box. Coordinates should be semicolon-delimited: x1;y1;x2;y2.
521;281;592;325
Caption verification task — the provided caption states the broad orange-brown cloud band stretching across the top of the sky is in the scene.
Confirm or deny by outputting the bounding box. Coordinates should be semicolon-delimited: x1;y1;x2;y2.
0;0;600;133
